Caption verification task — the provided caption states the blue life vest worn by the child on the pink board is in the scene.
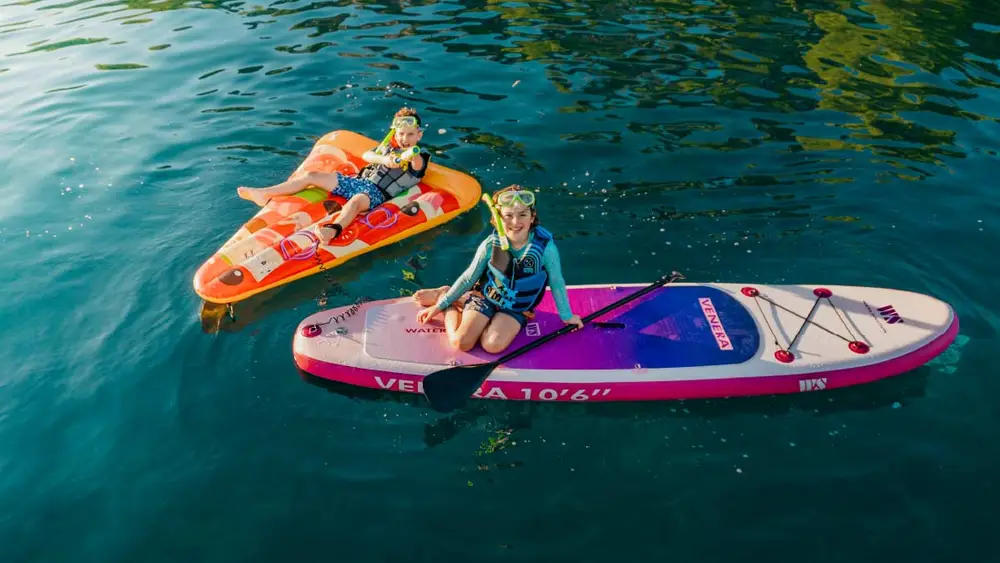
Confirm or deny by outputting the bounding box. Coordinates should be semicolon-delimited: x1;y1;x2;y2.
477;227;552;313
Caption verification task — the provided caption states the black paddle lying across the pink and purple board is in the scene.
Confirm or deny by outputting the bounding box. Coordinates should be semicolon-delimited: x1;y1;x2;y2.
423;272;684;412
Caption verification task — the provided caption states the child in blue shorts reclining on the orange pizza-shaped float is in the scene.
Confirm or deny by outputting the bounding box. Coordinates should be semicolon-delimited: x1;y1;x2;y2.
236;107;431;244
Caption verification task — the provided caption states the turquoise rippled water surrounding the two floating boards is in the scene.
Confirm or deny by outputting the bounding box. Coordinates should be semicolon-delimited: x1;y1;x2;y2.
0;0;1000;562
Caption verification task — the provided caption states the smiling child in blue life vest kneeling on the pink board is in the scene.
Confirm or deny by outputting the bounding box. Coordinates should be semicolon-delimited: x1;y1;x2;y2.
413;184;583;354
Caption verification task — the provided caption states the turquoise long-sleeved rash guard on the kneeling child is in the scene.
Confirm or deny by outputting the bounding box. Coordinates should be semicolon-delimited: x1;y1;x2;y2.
437;227;573;322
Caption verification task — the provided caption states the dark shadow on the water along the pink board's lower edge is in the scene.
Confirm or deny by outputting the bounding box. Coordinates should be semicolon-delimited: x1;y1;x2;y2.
298;366;935;447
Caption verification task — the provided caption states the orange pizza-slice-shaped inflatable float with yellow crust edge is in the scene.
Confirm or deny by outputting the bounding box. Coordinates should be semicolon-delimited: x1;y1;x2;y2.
194;131;482;303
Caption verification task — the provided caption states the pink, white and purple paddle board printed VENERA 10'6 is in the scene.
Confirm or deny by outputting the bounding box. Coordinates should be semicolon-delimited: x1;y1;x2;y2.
292;283;958;401
